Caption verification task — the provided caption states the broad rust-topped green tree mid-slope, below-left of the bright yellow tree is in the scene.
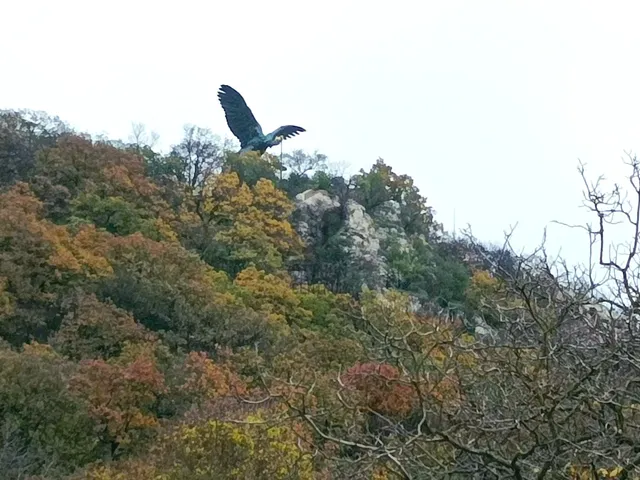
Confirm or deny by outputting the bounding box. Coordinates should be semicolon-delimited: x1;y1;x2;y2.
99;233;269;351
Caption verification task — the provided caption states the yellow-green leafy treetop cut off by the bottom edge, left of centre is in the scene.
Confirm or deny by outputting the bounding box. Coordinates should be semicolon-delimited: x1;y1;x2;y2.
78;417;314;480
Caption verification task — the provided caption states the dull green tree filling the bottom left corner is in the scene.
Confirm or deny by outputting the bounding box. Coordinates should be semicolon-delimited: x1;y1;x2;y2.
0;343;99;480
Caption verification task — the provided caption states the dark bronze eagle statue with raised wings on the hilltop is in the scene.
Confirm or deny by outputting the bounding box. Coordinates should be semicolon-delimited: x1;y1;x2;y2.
218;85;306;155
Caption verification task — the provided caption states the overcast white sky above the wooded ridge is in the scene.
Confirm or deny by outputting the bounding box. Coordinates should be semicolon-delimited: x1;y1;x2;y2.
0;0;640;266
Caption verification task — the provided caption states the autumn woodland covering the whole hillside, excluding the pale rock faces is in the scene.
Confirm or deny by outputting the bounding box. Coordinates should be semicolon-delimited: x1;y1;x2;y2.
0;111;640;480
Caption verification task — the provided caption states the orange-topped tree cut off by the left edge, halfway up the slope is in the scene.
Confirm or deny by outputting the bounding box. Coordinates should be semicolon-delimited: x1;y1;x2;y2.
0;183;112;344
